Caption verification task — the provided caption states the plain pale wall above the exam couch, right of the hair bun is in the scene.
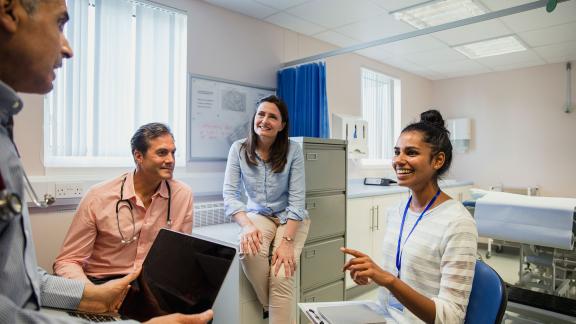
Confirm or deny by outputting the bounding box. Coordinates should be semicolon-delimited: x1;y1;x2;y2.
432;64;576;197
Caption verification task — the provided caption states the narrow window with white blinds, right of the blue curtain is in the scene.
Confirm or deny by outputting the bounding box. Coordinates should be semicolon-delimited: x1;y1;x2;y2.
362;69;400;164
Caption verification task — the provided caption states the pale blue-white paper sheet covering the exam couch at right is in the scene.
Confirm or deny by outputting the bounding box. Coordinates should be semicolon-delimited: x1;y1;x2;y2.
474;192;576;250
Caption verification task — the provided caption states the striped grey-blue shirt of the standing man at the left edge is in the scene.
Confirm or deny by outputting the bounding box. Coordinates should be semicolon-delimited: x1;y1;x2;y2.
0;81;92;323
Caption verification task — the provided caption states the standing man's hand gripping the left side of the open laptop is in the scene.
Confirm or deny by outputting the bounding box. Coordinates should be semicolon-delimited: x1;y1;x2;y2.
78;270;140;313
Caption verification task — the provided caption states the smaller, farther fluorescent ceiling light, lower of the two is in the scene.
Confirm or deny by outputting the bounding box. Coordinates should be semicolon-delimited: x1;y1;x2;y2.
453;36;526;59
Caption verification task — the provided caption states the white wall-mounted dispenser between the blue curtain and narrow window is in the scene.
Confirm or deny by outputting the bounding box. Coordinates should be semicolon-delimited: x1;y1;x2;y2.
332;114;368;159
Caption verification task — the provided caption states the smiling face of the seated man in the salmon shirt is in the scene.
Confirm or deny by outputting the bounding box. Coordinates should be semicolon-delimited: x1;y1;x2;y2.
134;134;176;181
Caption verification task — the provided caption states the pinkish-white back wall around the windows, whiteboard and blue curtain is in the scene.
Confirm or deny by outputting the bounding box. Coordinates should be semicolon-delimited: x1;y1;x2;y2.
20;0;431;269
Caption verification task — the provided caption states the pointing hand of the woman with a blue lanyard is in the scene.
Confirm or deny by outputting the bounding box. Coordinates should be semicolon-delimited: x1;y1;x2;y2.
340;248;396;287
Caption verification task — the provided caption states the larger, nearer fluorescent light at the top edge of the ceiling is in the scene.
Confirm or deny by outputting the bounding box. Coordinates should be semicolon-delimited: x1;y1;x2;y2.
390;0;487;29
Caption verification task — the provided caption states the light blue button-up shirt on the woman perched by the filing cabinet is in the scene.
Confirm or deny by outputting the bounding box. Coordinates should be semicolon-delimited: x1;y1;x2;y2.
223;139;308;224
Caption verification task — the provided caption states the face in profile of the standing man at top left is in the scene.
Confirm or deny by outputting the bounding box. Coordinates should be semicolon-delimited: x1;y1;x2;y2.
0;0;72;94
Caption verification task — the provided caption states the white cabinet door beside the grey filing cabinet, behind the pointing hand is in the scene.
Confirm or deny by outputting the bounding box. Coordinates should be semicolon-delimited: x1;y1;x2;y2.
346;198;374;289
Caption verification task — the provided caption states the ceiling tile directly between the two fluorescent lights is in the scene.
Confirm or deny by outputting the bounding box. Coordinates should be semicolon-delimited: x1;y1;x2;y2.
431;20;511;45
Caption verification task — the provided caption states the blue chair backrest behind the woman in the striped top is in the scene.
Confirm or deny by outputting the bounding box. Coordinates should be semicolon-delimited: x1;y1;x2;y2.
464;260;508;324
